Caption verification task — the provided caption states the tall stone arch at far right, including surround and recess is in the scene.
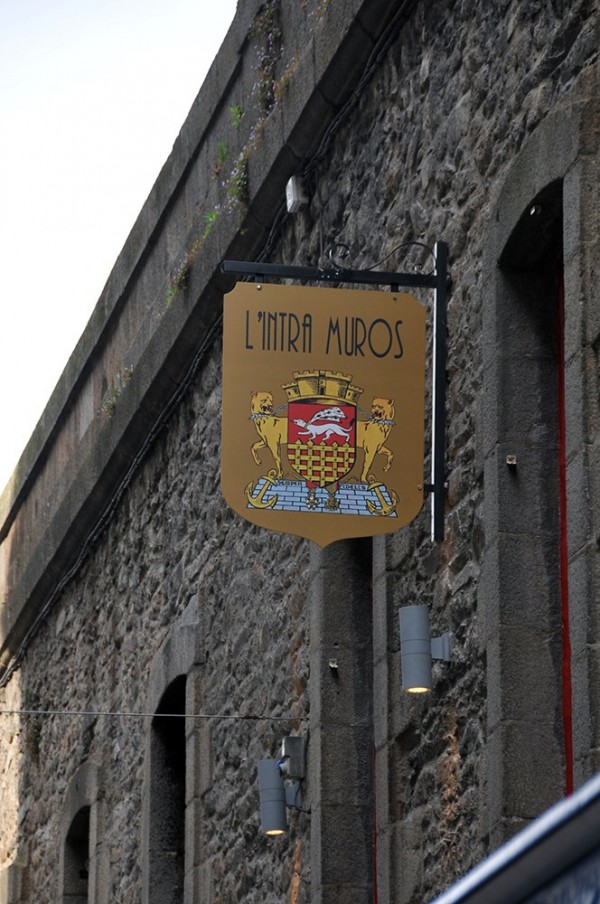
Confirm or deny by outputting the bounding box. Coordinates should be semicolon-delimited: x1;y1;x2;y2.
479;67;600;847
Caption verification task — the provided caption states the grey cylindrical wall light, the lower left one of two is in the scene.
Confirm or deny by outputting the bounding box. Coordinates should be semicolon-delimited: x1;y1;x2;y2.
258;737;304;835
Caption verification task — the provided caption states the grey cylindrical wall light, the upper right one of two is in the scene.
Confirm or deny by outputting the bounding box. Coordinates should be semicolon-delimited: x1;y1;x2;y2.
398;606;450;694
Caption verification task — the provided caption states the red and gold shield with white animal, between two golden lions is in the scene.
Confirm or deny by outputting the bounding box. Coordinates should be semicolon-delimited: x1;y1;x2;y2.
287;399;356;487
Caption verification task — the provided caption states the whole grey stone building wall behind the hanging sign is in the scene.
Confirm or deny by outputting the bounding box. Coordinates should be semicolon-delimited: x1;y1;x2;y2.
0;0;600;904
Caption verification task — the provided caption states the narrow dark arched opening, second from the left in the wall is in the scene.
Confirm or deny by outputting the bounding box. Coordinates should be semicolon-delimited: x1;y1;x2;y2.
149;675;186;904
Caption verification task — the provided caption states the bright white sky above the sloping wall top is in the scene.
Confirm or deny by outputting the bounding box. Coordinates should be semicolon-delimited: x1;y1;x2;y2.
0;0;236;493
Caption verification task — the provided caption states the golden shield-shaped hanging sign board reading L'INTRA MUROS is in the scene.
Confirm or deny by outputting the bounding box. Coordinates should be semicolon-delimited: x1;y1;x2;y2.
221;283;426;546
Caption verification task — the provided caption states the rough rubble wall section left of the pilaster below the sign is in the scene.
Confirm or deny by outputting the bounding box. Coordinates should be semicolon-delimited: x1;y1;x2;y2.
5;347;308;902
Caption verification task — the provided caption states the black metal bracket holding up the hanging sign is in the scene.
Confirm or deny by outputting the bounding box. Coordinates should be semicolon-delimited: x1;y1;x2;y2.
221;242;449;541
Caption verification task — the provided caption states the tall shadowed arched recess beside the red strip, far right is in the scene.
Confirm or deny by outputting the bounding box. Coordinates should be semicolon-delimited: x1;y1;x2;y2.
486;173;572;820
